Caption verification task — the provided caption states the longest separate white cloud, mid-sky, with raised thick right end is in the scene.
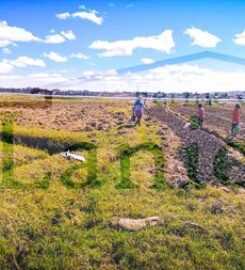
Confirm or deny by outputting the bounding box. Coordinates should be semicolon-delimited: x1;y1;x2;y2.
90;30;175;57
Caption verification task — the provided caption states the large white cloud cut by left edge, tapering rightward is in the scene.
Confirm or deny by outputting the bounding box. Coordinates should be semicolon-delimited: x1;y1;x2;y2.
0;21;40;48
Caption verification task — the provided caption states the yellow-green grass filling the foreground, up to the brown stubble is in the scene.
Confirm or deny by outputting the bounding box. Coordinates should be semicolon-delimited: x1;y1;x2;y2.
0;98;245;270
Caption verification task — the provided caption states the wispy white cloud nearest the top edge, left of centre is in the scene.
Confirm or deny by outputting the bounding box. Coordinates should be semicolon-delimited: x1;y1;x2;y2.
56;6;103;25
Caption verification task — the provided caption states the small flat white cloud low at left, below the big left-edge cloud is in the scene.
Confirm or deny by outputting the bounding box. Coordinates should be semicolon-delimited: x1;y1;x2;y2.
4;56;46;68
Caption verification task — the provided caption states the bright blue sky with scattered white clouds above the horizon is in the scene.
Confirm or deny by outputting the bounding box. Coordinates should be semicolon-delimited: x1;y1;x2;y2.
0;0;245;92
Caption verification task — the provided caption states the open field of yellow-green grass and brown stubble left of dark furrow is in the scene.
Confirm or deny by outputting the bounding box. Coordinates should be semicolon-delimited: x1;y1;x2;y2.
0;97;245;270
